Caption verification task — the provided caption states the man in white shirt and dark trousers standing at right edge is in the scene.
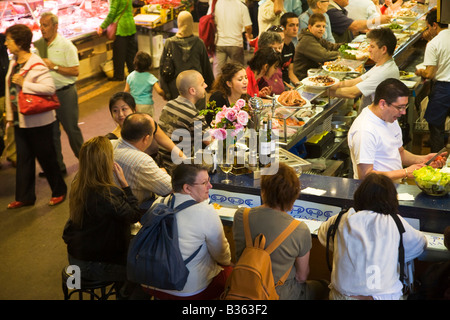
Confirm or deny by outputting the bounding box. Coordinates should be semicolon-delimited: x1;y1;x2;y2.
416;9;450;152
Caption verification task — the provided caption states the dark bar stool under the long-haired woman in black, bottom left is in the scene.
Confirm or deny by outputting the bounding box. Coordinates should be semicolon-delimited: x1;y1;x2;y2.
62;266;118;300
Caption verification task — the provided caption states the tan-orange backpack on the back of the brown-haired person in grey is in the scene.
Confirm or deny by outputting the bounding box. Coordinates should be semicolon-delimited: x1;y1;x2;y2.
221;208;300;300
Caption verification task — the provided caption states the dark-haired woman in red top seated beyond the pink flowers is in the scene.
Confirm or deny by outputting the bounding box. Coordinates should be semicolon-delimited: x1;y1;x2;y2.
246;47;281;97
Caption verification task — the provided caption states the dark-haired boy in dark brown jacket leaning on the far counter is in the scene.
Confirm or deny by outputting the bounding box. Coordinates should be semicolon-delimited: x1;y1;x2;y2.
294;13;341;79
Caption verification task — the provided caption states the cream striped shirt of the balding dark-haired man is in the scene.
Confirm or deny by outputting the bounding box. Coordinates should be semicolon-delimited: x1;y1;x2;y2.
111;138;172;203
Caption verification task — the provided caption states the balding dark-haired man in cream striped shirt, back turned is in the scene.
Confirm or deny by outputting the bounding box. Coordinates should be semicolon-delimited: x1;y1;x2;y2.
111;113;172;209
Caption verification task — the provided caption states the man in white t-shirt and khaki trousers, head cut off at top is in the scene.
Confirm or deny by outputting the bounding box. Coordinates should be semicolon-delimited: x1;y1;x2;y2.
213;0;253;77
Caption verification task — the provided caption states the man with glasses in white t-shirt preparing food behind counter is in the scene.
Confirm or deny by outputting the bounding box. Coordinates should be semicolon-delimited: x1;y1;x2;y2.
347;78;447;181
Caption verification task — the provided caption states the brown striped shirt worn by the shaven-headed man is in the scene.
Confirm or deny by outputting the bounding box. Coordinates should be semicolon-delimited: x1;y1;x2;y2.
158;96;207;170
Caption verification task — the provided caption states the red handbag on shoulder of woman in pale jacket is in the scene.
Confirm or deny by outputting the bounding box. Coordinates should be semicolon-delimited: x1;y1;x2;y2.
17;62;60;115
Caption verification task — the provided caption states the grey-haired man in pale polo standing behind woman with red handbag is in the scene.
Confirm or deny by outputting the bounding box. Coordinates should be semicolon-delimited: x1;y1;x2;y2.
34;12;84;177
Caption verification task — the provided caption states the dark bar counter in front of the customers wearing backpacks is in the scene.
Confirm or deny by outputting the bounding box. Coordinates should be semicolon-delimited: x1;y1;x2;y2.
211;170;450;234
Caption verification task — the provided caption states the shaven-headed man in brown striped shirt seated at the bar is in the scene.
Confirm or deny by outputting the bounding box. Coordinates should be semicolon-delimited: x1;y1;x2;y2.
158;70;209;171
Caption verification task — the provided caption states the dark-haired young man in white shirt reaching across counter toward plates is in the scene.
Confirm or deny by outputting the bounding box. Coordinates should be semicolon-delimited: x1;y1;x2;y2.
330;28;400;111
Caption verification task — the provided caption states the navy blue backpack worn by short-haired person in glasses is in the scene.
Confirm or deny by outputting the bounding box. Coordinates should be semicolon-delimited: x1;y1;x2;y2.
127;194;202;290
